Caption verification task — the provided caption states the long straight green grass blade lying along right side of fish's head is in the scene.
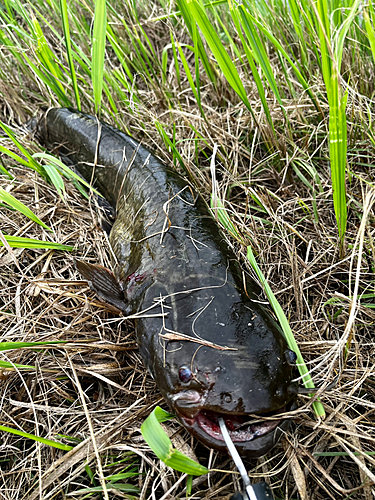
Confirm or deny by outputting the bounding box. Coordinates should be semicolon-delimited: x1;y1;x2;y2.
247;246;325;418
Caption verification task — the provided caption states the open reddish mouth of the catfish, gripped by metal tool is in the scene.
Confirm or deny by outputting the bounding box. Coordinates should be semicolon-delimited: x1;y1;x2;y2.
178;407;289;458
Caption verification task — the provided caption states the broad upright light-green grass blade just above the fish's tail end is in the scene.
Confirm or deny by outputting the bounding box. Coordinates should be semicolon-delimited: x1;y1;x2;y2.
91;0;107;113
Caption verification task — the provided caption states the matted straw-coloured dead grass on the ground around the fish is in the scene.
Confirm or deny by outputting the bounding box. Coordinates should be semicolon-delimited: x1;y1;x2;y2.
0;91;375;500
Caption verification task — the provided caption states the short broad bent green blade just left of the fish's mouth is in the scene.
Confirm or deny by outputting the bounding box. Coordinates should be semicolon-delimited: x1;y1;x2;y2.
141;406;209;476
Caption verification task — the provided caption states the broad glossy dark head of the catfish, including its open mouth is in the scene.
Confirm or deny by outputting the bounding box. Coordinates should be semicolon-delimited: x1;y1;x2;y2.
158;305;296;457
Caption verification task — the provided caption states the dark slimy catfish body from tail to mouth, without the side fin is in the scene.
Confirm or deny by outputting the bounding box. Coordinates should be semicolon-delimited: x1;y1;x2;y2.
37;109;296;457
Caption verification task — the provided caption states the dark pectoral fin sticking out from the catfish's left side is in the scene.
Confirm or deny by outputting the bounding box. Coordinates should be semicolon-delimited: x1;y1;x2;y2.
74;260;131;314
